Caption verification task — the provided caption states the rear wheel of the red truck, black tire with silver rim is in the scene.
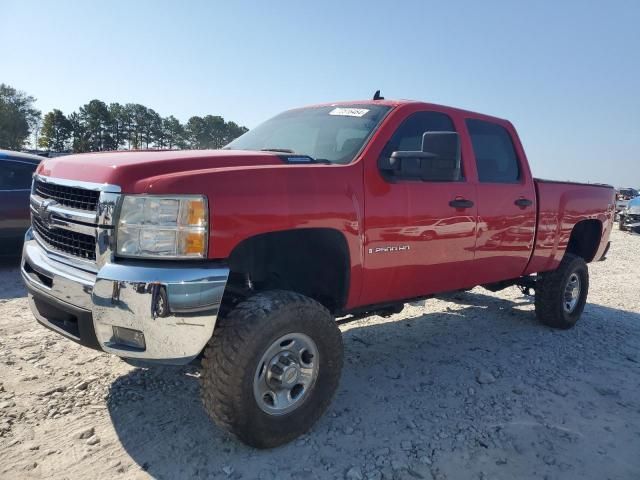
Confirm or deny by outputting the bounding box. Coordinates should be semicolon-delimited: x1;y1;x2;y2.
535;253;589;330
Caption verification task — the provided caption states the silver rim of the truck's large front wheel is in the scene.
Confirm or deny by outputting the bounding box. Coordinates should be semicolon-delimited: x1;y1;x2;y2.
253;333;320;415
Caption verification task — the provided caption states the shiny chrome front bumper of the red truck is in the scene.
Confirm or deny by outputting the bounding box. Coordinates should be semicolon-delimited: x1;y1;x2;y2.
21;233;229;364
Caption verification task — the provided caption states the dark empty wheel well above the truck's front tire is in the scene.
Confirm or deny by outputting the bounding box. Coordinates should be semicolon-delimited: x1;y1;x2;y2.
228;228;349;312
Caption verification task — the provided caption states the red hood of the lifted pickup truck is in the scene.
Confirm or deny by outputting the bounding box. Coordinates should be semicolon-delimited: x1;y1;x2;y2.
37;150;284;193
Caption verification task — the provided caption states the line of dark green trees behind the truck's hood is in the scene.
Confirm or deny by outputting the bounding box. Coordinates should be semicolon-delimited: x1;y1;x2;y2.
0;84;247;152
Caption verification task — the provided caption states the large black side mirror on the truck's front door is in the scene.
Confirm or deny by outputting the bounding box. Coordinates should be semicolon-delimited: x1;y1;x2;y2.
378;132;460;182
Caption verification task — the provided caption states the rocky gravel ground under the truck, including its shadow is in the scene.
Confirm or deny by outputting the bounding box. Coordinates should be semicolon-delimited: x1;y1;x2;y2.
0;231;640;479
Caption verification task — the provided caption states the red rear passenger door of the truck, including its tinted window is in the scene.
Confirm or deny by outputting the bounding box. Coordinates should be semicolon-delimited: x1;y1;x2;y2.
466;119;536;283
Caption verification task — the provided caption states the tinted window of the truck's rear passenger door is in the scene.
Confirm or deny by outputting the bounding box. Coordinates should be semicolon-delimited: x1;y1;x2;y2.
466;119;520;183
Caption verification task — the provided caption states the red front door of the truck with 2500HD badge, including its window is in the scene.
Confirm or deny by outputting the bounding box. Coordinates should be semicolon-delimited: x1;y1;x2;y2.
360;111;477;305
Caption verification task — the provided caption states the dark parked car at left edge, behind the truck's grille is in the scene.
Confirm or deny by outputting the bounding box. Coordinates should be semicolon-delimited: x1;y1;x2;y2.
0;150;42;255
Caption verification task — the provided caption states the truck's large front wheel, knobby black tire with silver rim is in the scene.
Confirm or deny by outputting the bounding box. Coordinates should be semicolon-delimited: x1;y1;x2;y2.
202;291;343;448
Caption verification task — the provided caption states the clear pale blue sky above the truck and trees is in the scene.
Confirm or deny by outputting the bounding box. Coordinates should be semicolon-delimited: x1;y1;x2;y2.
0;0;640;187
